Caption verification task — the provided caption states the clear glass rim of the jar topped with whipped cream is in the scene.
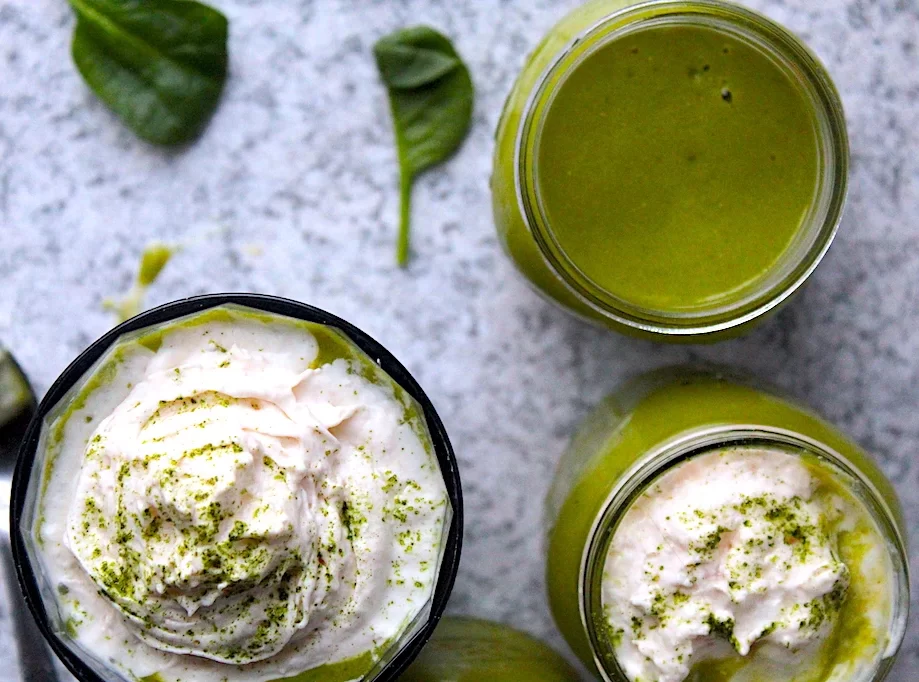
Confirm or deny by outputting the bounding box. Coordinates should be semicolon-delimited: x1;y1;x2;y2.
578;424;910;682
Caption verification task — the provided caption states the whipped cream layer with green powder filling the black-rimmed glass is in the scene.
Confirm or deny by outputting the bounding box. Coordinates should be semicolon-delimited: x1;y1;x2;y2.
34;314;447;680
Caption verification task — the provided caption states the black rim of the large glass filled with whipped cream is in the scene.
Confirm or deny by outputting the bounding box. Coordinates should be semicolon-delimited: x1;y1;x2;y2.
10;293;463;682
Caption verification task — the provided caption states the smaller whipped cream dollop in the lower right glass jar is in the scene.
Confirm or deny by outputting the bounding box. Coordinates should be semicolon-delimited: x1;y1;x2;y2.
602;448;849;682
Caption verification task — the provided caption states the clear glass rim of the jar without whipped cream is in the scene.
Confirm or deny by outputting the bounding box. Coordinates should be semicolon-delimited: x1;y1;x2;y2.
514;0;849;337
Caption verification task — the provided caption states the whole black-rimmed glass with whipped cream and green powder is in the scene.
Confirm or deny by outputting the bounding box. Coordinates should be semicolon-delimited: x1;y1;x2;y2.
11;294;462;682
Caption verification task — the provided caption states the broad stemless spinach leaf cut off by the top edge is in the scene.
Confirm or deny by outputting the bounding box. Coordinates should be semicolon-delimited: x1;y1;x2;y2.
70;0;228;145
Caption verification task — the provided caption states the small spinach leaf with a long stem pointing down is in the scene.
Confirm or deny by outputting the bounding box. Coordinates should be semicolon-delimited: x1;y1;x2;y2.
373;26;473;265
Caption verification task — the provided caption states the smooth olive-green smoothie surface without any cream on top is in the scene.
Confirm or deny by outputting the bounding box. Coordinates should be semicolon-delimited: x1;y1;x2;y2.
537;24;819;312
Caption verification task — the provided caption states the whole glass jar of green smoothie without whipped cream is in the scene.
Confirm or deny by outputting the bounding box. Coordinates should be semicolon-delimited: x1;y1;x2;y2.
491;0;848;342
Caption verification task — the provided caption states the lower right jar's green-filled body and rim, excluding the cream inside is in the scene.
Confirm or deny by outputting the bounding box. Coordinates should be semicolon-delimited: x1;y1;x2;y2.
547;368;909;682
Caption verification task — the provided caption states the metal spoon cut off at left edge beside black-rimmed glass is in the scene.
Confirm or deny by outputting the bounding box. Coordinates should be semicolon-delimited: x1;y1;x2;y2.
0;348;58;682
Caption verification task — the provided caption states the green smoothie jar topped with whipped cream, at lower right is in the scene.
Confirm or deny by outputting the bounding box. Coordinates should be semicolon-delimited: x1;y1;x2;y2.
547;369;909;682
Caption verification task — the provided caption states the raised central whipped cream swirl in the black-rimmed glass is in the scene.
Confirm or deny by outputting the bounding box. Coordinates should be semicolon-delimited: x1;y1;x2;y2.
67;347;392;663
